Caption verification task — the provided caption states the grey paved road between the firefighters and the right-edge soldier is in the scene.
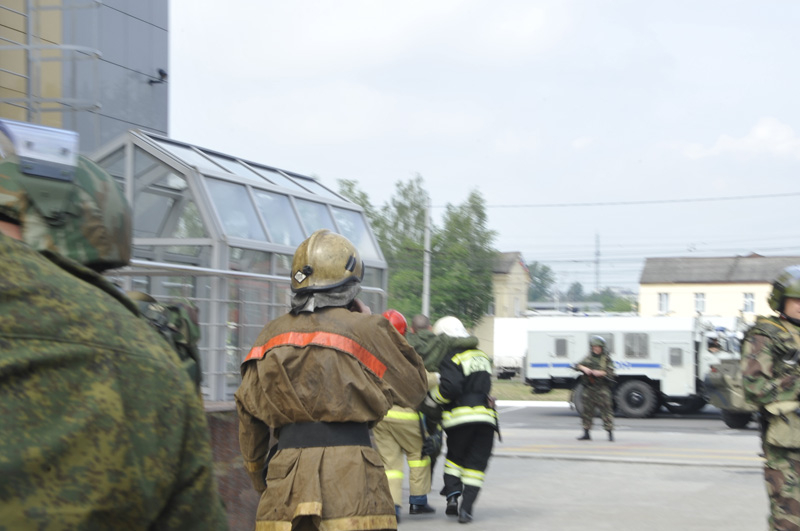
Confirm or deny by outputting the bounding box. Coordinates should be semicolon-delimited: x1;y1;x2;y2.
400;403;768;531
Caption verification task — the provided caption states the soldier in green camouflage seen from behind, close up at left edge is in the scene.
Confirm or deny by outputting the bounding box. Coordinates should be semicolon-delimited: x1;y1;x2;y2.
0;121;227;531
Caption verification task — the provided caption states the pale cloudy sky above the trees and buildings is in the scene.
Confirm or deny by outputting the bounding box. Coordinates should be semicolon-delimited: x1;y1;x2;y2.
169;0;800;292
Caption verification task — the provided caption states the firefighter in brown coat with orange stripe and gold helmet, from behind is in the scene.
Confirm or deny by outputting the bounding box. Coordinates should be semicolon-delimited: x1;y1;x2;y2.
235;229;427;531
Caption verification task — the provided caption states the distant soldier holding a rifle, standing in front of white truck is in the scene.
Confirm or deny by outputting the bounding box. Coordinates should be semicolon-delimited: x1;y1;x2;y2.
575;336;616;441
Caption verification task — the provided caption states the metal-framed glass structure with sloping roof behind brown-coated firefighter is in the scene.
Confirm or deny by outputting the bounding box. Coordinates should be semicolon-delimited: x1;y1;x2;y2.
92;130;387;401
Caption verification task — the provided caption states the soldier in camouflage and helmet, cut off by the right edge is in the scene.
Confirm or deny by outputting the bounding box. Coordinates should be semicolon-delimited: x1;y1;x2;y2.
741;266;800;531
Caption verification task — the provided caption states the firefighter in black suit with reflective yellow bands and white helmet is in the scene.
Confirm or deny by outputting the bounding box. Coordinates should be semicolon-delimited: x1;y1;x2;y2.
421;316;497;523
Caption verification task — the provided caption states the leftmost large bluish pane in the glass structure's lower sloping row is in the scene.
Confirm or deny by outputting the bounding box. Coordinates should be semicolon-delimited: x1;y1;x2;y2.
206;177;267;241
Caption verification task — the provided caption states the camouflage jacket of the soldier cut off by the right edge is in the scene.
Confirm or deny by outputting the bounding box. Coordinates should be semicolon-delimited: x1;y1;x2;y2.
741;317;800;408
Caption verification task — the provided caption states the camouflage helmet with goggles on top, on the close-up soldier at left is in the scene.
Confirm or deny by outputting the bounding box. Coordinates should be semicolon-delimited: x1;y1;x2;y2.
0;120;132;271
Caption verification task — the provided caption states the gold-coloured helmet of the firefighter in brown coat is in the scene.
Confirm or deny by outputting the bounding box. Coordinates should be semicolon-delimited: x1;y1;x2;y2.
292;229;364;293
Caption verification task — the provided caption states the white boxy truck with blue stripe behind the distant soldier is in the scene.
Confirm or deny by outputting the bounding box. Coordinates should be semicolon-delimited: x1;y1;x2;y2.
495;316;736;418
